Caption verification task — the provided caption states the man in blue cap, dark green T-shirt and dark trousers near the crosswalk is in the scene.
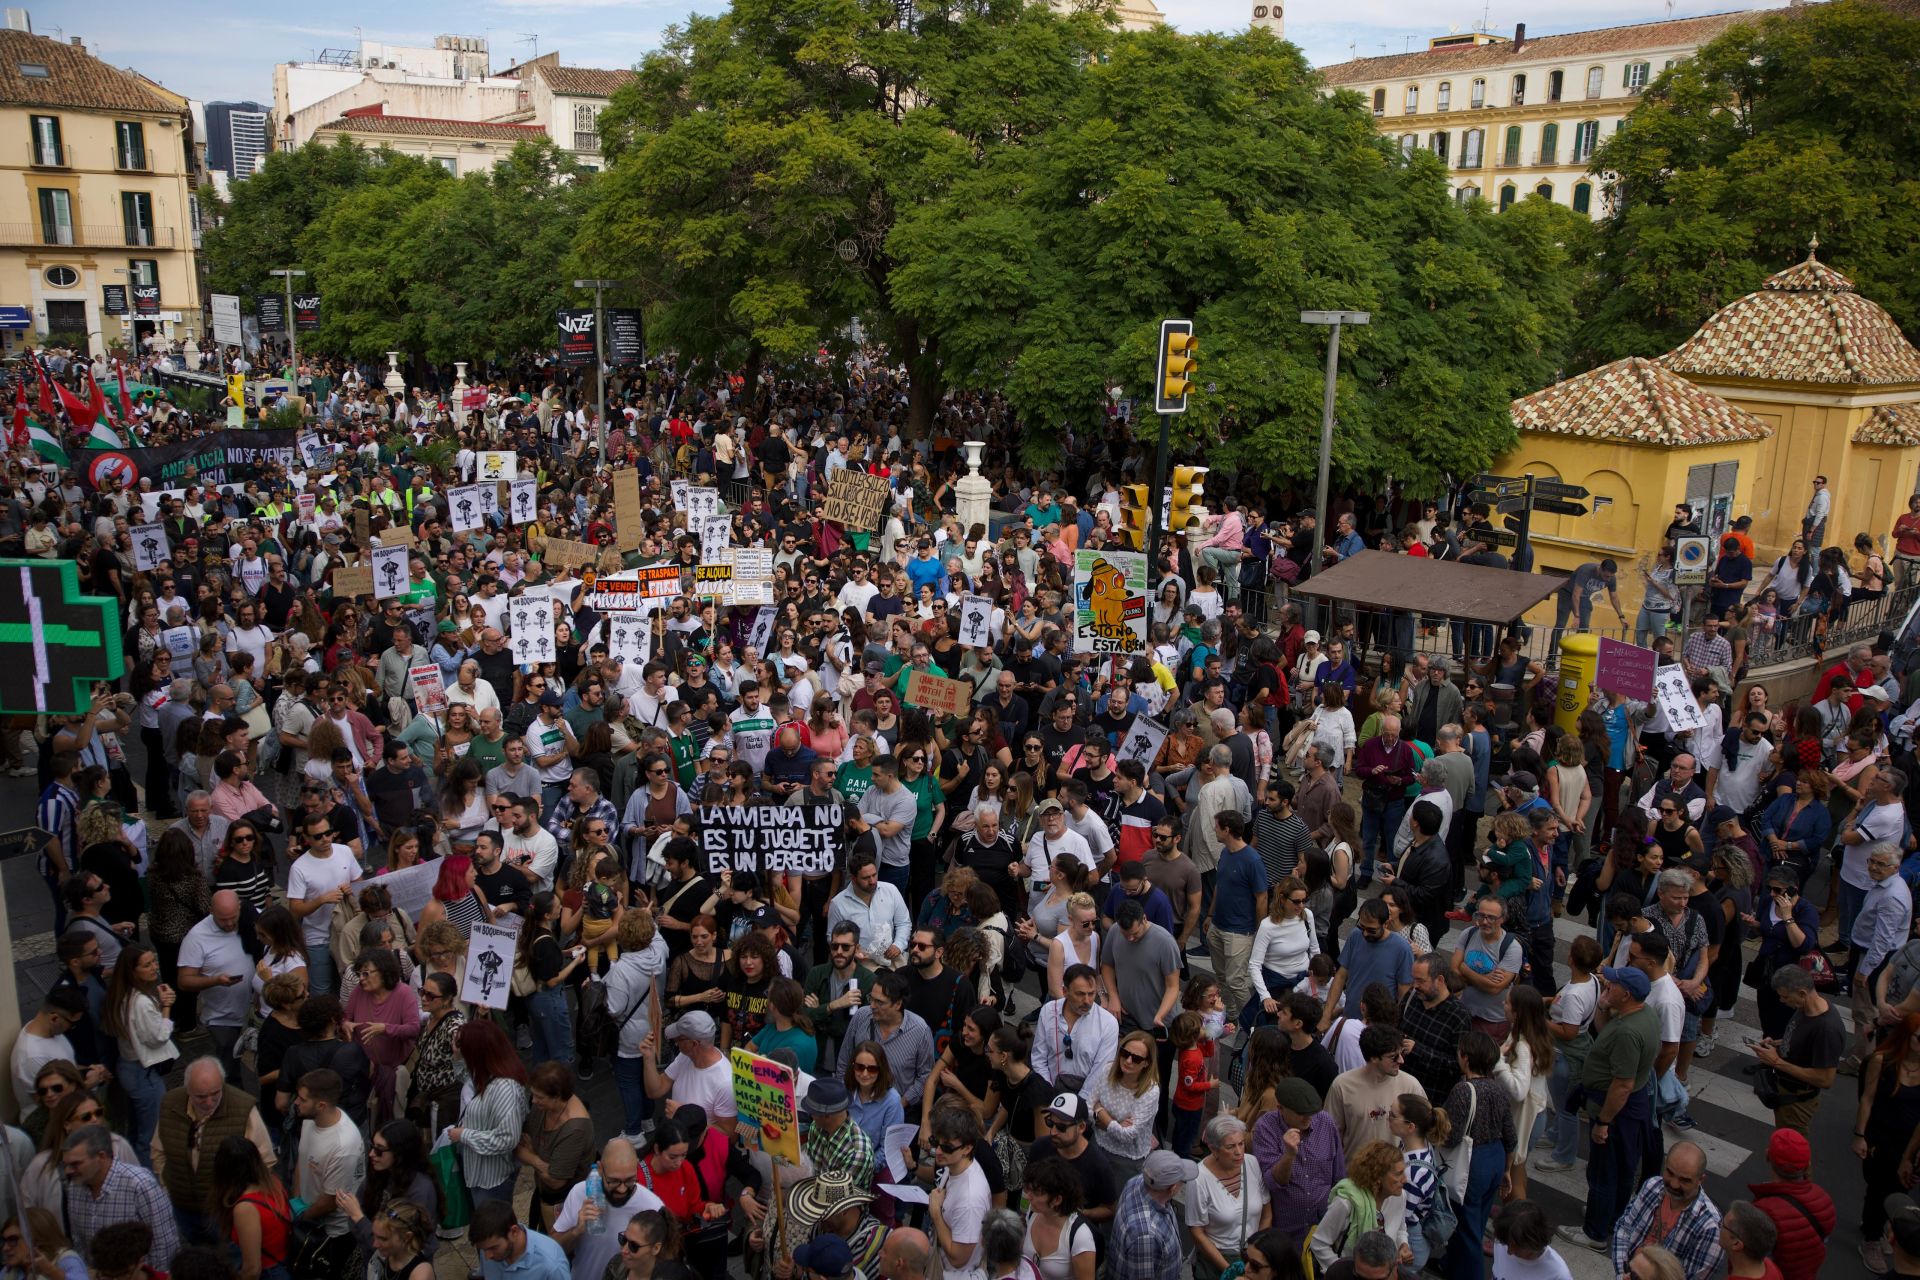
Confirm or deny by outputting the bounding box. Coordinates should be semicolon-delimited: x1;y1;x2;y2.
1559;967;1661;1251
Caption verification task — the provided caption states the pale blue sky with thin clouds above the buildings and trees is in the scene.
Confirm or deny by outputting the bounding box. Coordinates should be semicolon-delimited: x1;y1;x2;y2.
56;0;1786;104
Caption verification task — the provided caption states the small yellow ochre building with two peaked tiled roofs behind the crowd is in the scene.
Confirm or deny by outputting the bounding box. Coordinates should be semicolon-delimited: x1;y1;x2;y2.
1494;246;1920;594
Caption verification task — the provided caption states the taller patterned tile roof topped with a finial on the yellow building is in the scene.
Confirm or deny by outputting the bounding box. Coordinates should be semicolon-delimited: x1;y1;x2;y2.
1661;242;1920;386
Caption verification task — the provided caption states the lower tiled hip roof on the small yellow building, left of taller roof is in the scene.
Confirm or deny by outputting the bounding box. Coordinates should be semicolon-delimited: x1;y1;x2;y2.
1513;355;1774;449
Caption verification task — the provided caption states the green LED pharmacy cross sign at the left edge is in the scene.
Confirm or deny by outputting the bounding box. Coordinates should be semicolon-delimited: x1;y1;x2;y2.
0;560;127;716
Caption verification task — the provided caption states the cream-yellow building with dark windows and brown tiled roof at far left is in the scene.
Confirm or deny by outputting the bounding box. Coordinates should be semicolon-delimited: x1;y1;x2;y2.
0;29;202;353
